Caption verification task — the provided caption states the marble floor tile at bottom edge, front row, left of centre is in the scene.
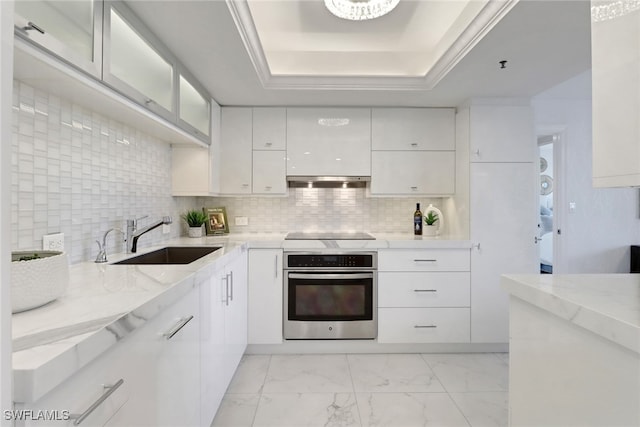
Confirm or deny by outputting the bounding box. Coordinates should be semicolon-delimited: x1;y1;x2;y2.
253;393;360;427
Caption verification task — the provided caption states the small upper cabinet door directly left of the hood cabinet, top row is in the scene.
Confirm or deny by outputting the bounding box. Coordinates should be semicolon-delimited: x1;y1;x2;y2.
253;107;287;150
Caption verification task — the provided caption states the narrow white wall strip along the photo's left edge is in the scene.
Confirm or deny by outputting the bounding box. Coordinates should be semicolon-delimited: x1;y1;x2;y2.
0;0;14;426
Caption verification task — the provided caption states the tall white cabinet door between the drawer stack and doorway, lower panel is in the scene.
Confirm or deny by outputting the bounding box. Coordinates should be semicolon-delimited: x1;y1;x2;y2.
470;163;539;343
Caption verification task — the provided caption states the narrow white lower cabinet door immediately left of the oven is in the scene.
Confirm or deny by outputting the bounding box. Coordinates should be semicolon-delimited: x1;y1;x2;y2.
248;249;283;344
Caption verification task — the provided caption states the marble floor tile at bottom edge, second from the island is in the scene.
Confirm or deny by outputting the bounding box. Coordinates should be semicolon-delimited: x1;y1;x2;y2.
356;393;469;427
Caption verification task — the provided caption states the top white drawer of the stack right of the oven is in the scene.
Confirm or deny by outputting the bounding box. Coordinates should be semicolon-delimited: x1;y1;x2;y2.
378;249;471;271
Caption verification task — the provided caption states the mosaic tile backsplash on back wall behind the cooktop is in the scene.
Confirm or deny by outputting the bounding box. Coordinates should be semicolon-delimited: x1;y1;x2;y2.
197;188;445;233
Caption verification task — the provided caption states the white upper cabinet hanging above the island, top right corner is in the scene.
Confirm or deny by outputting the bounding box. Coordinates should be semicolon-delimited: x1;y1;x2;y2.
591;0;640;187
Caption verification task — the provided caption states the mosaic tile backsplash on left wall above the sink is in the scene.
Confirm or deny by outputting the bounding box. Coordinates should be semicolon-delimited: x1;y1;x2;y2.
11;81;195;263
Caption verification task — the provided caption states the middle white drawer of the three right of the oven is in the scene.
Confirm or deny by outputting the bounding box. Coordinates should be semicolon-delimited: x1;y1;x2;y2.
378;271;471;307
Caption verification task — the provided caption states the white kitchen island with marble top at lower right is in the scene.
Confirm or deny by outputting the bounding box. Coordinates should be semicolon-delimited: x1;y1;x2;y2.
502;274;640;427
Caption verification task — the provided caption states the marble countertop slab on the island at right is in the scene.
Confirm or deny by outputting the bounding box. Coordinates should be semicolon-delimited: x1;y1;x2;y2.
501;274;640;353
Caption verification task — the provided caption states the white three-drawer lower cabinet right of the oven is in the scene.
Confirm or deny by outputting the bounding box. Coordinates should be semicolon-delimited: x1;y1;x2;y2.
378;249;471;343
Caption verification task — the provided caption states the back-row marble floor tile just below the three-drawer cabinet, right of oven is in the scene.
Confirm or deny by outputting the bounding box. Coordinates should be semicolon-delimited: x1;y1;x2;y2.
347;354;444;392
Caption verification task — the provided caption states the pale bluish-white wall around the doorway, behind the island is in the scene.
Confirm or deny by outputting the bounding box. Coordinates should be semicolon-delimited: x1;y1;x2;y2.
532;72;640;273
